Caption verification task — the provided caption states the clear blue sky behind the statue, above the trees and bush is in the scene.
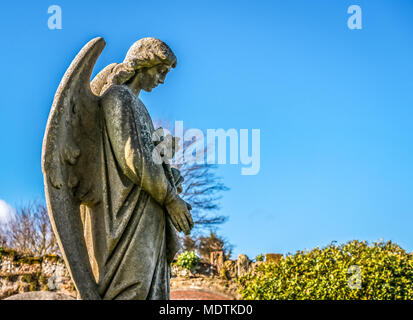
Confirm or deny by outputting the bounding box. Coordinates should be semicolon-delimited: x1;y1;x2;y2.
0;0;413;257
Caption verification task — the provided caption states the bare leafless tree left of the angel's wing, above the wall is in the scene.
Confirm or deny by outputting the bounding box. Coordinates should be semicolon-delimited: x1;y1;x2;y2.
2;203;59;256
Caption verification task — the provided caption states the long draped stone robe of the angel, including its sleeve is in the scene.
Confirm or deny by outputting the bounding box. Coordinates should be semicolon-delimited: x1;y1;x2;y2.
81;85;179;300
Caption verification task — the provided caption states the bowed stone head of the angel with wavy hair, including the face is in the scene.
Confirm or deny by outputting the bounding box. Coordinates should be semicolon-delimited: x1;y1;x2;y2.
92;38;177;95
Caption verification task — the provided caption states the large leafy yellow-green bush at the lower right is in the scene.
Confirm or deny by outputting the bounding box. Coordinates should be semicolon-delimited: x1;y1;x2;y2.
238;240;413;300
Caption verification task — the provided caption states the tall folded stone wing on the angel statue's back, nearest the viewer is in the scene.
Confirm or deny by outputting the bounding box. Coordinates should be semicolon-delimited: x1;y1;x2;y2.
42;37;105;299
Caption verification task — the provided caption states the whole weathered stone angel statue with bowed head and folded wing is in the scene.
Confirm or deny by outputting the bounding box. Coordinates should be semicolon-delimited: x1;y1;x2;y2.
42;37;193;300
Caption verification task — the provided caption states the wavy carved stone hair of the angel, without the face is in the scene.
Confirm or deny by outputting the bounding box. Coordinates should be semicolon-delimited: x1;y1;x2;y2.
91;38;177;95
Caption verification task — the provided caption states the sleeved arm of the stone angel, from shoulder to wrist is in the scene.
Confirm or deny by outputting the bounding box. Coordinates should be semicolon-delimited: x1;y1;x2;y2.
101;86;176;205
